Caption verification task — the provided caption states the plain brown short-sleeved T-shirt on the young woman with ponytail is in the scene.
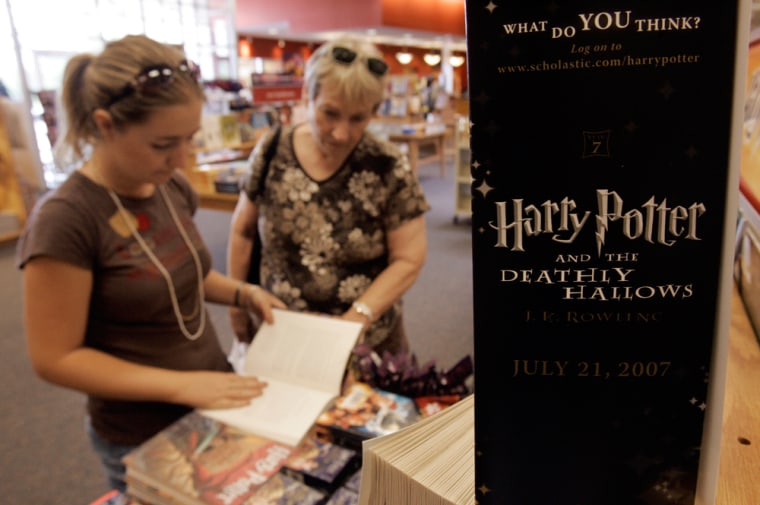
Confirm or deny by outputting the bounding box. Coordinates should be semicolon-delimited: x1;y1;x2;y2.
17;172;230;445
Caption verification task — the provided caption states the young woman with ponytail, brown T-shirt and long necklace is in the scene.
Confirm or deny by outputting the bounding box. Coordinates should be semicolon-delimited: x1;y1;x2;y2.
17;36;284;489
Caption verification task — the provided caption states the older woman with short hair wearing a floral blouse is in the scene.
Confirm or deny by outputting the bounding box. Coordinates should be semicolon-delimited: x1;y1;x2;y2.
228;35;429;353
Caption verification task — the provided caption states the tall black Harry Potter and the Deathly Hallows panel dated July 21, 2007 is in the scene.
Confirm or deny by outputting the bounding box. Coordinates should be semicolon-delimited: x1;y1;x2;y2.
466;0;749;505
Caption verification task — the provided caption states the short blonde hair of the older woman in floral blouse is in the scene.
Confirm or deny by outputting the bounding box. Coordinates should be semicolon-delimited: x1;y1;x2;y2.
304;37;386;108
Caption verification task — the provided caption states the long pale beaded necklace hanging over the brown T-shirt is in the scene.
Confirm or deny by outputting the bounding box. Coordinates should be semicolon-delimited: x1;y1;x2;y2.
106;186;206;340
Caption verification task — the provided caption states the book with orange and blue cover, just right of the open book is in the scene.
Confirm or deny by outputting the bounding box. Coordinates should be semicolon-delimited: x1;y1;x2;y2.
317;382;420;451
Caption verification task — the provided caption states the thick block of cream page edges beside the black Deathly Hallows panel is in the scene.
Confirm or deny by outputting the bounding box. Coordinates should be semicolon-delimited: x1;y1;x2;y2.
359;394;475;505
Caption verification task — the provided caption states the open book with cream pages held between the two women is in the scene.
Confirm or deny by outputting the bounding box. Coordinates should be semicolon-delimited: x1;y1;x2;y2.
200;309;362;446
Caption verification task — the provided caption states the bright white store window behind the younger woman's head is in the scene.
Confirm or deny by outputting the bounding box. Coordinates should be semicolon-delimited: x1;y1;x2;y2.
0;0;237;187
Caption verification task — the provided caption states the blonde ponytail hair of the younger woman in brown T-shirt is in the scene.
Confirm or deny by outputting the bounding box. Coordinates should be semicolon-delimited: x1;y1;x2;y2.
55;35;204;165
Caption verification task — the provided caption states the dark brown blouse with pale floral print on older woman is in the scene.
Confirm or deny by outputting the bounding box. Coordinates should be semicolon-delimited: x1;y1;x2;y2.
241;126;430;346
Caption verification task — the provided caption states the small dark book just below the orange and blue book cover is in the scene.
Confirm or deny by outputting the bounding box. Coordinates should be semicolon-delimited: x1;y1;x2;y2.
280;437;359;491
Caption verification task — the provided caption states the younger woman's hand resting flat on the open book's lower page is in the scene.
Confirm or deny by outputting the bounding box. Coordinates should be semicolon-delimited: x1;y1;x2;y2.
173;371;267;409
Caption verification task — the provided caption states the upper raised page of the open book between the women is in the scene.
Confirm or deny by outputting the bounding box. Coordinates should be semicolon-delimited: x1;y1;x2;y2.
245;309;362;395
